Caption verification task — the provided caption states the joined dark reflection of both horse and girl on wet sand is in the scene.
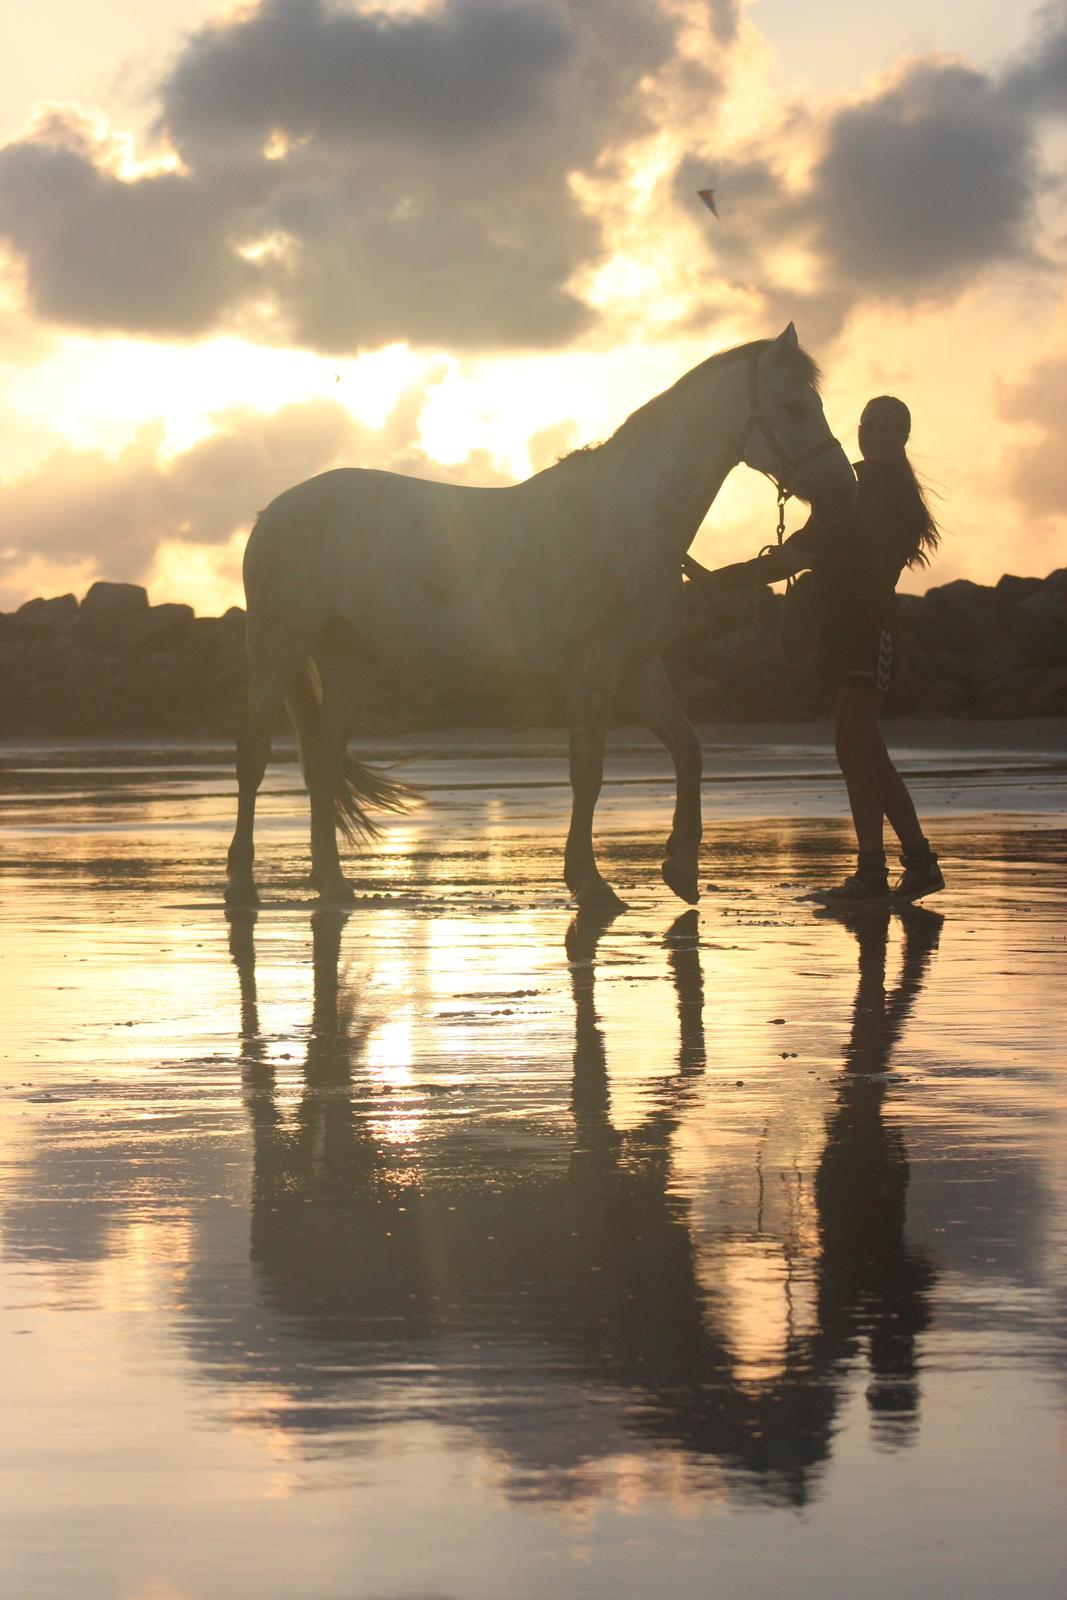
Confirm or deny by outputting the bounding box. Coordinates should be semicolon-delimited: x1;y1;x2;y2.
205;910;933;1504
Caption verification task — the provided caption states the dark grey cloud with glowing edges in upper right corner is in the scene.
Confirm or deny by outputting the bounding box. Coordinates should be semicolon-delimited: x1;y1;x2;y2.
673;5;1067;338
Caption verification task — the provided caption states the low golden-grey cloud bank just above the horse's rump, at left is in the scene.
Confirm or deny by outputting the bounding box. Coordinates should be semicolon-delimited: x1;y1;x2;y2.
0;376;512;595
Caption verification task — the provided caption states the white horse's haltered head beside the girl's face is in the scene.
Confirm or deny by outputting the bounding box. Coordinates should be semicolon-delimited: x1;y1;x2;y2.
737;322;856;514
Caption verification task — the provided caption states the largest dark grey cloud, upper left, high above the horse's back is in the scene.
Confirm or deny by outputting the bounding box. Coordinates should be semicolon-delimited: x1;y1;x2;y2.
0;0;716;352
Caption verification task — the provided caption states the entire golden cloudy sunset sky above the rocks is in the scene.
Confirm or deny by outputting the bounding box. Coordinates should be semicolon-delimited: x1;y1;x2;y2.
0;0;1067;613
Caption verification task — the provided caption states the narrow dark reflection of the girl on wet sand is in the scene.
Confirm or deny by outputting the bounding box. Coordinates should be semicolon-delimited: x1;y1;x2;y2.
816;907;942;1440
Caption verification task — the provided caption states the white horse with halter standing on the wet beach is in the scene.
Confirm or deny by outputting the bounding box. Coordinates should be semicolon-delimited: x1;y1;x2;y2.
227;323;856;910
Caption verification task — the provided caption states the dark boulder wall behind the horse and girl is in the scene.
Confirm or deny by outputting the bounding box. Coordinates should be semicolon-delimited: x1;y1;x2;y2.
0;568;1067;734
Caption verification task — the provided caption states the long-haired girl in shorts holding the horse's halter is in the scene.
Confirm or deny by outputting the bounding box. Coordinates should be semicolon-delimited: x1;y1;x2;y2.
686;395;944;902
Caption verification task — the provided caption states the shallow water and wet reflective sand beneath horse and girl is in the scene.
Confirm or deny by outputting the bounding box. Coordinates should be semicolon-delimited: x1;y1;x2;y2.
0;734;1067;1600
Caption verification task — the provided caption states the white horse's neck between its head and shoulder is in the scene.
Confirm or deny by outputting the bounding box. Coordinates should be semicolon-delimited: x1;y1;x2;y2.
605;365;747;560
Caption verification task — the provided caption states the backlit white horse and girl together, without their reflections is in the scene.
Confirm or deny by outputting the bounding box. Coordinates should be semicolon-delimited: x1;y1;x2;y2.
227;323;944;912
